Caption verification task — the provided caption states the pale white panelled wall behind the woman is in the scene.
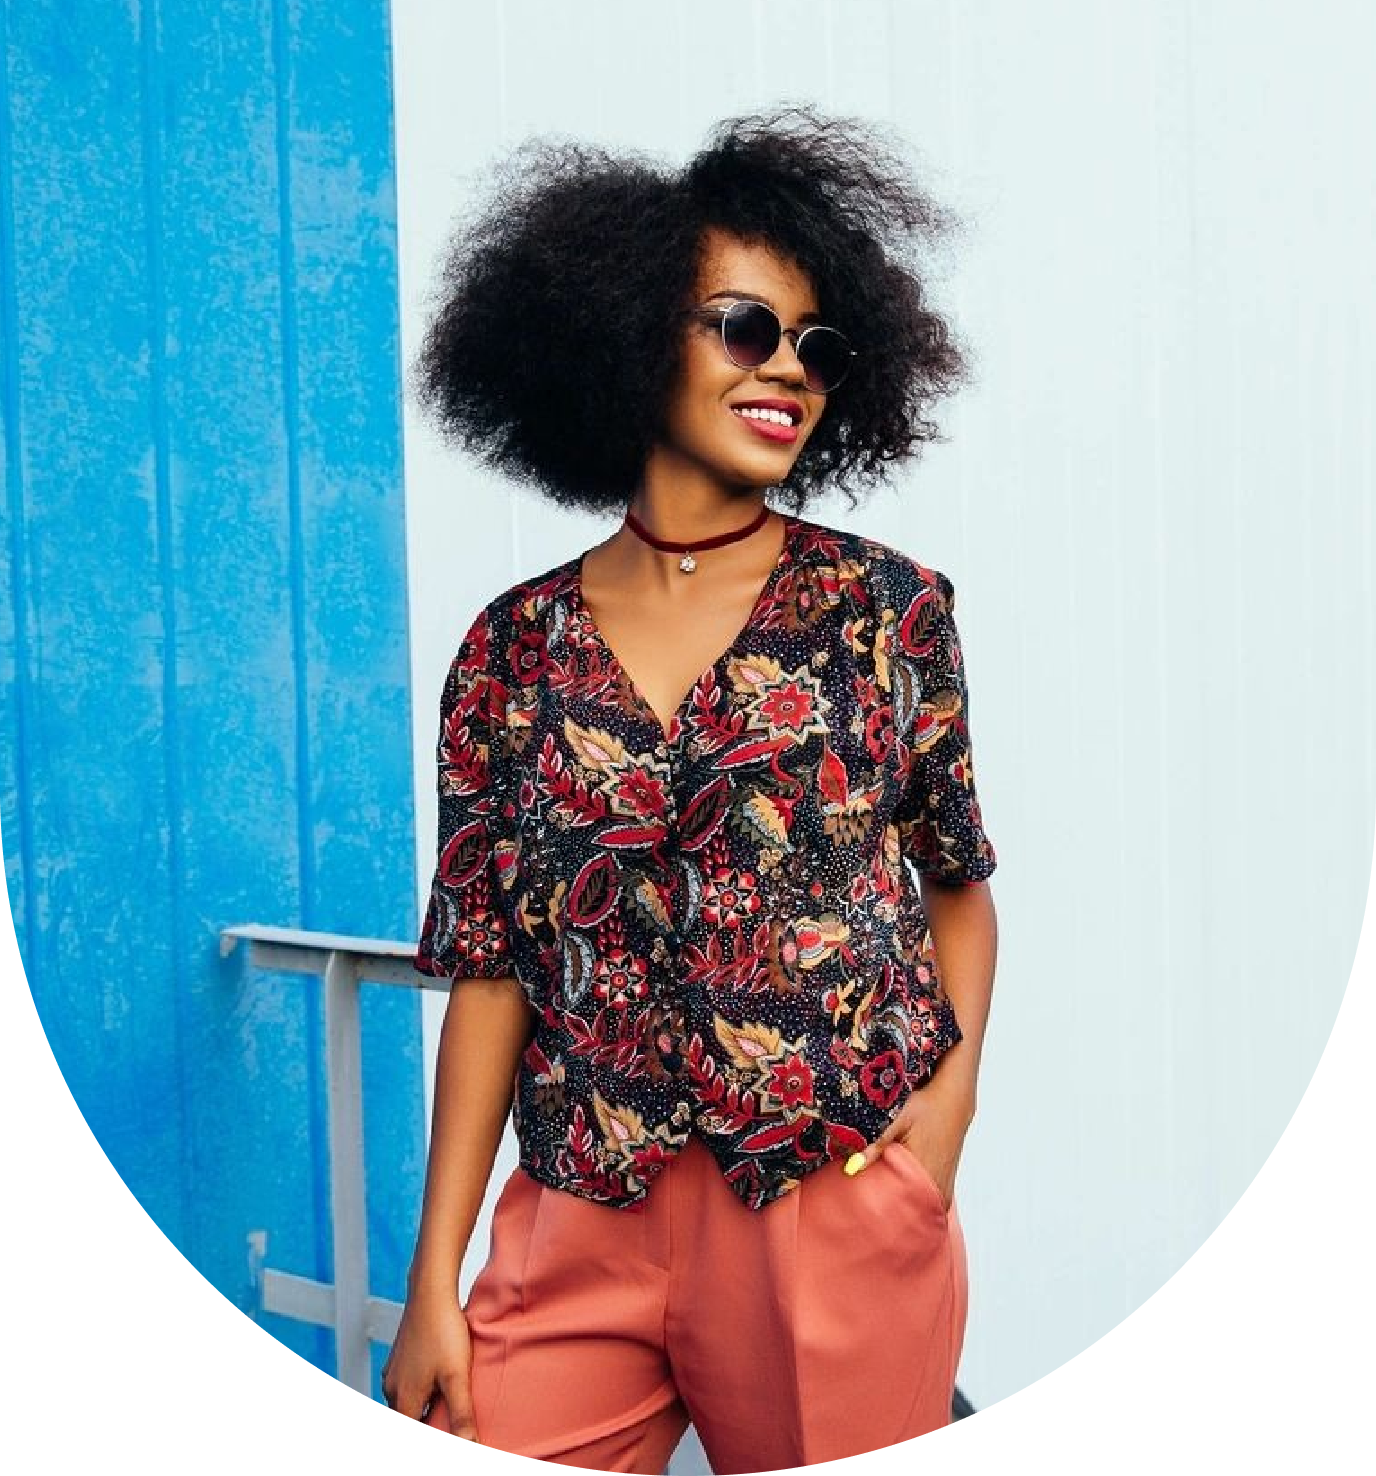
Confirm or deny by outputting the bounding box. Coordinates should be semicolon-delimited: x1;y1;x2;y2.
393;0;1376;1408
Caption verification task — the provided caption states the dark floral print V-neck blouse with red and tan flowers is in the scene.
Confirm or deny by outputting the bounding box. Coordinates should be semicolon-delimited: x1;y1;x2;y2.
415;514;995;1209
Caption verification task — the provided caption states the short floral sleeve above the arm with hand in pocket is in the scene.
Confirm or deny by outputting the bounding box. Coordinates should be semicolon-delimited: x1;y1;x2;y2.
890;564;997;883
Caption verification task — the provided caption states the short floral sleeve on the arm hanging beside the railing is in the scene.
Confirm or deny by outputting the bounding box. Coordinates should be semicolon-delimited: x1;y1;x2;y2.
415;610;514;979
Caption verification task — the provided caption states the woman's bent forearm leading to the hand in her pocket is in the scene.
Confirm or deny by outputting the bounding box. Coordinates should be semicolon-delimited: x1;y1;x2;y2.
921;877;998;1114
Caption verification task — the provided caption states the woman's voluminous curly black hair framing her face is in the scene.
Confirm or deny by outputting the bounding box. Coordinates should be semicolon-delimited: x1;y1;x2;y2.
412;103;970;512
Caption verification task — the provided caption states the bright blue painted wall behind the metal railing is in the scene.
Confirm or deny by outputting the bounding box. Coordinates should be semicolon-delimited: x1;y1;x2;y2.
0;0;424;1399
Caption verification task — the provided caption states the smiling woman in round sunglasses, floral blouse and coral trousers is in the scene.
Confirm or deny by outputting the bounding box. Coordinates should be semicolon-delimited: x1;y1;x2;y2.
382;108;995;1473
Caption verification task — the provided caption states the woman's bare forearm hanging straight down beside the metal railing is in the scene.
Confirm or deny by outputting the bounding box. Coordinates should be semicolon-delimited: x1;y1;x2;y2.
409;977;534;1293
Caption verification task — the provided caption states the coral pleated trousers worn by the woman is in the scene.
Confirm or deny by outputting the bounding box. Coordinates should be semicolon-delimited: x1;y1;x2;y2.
465;1137;967;1476
